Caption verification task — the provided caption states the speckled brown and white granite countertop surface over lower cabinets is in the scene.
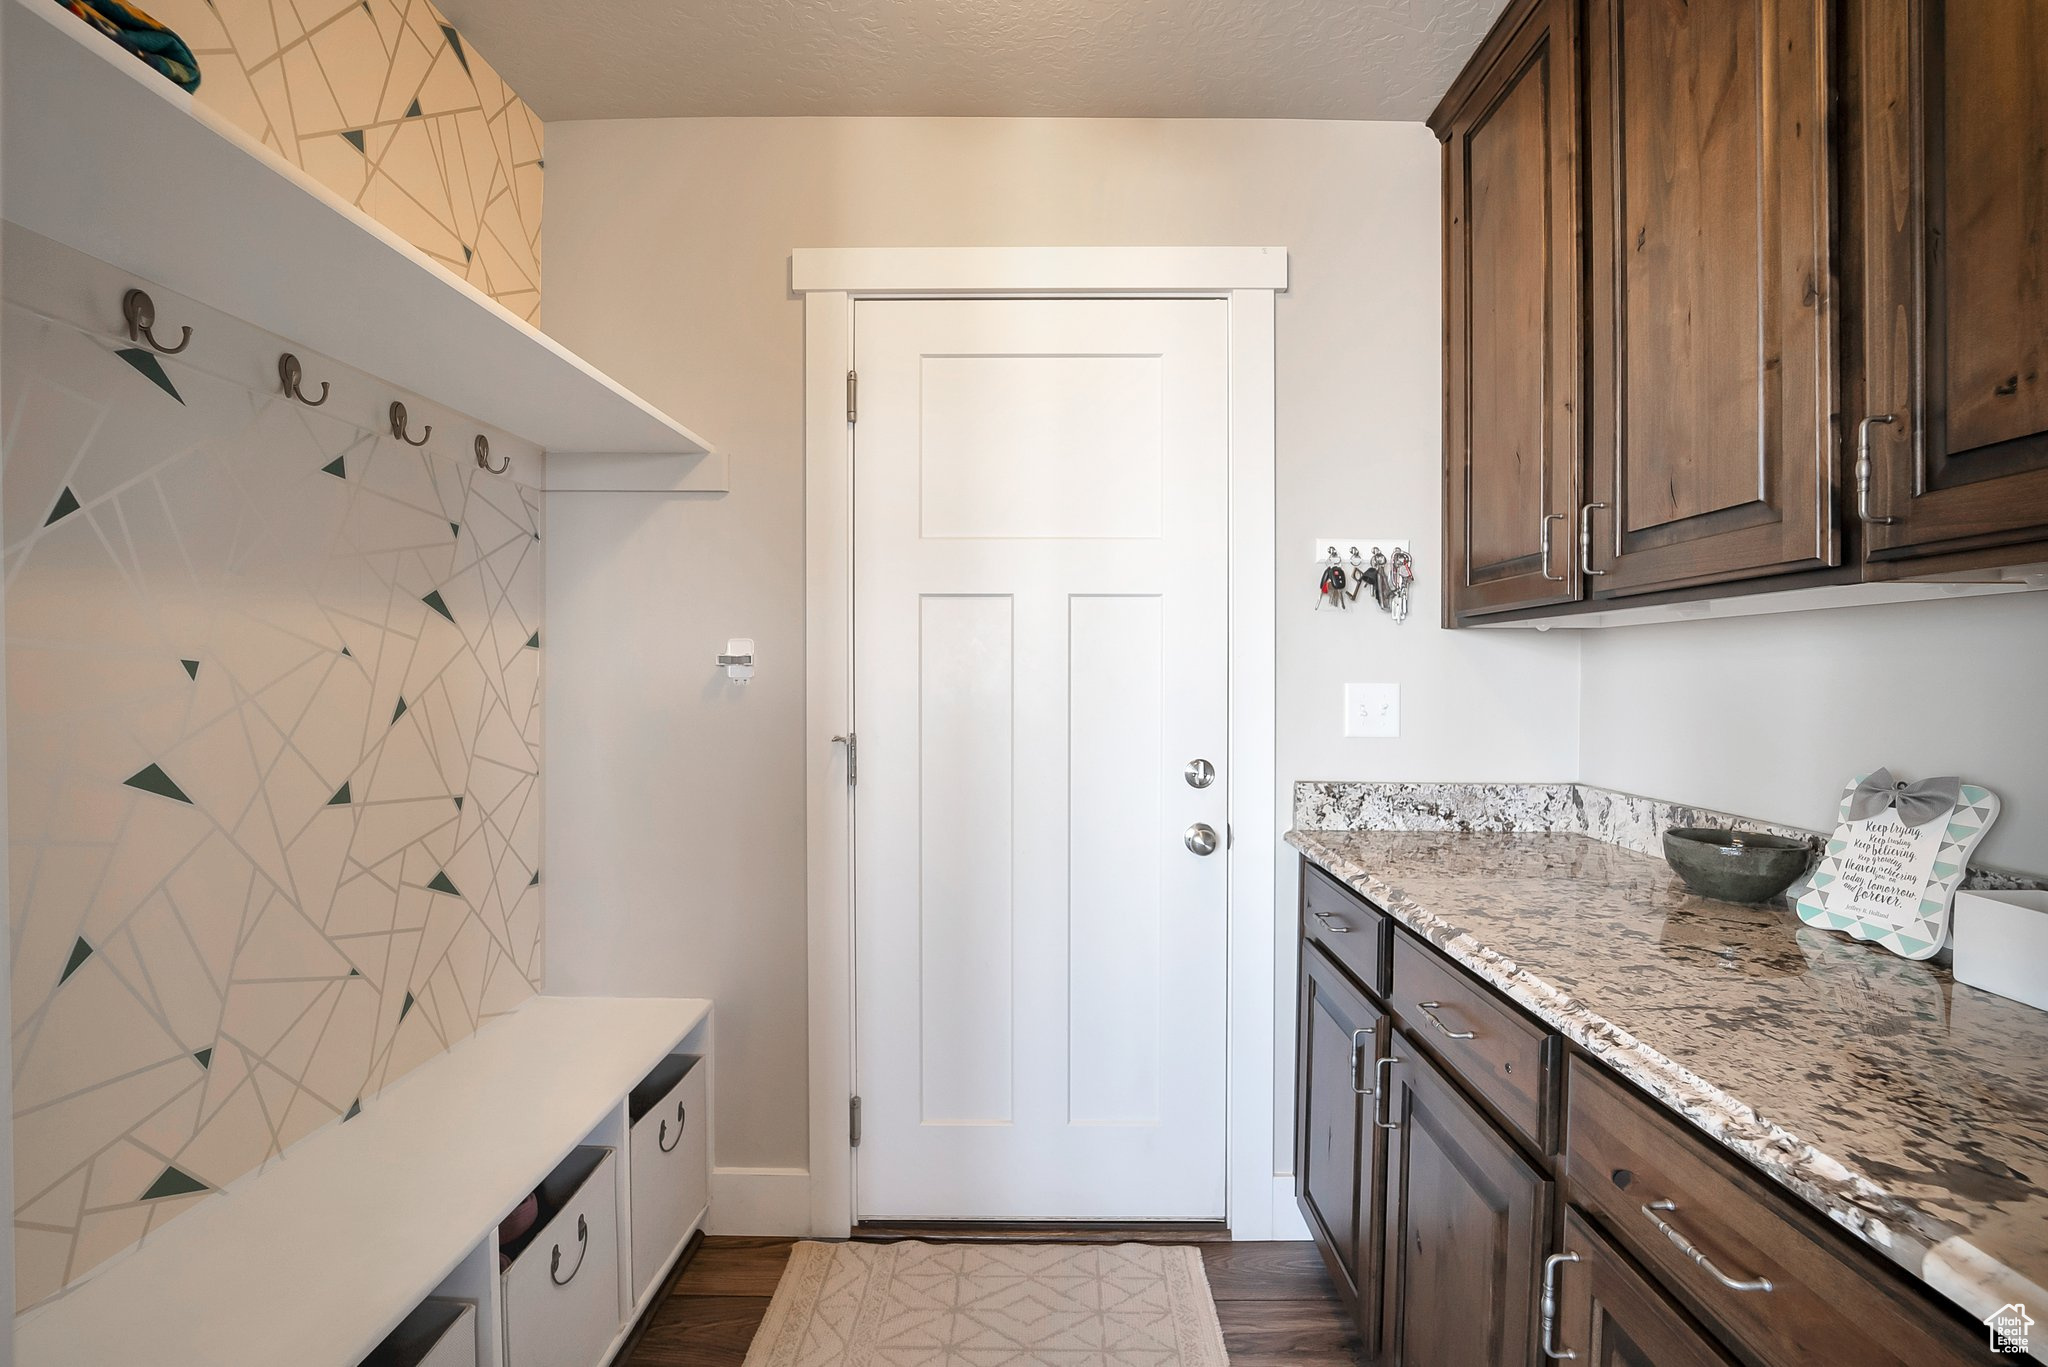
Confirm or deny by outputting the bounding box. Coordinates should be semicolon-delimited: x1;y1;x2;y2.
1286;830;2048;1316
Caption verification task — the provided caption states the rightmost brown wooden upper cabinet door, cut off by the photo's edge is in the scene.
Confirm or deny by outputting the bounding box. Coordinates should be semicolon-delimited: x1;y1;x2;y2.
1847;0;2048;560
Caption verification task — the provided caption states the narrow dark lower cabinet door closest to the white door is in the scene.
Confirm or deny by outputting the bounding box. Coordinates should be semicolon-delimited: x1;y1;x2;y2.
1294;941;1386;1342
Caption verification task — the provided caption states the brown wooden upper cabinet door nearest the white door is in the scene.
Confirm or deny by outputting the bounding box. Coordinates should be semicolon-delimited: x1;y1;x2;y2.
1438;0;1581;621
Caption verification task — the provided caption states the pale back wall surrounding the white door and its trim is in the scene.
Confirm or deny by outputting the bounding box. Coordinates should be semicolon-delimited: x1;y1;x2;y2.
547;119;1579;1168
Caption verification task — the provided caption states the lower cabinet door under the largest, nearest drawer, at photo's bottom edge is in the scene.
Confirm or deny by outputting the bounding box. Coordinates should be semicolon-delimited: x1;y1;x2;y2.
1542;1209;1733;1367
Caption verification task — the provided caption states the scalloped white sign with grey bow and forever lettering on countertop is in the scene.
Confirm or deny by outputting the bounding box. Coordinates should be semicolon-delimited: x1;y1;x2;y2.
1798;769;1999;959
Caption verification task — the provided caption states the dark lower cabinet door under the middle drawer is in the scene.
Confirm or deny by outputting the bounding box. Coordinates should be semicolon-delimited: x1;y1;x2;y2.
1380;1031;1550;1367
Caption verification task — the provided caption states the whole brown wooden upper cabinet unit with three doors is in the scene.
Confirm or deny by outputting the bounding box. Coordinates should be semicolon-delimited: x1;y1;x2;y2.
1430;0;2048;625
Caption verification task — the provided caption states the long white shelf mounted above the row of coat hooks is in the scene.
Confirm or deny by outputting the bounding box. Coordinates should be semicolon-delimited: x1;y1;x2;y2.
0;0;723;467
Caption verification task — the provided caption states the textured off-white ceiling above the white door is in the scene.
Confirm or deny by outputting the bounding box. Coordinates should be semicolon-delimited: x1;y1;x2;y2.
442;0;1505;119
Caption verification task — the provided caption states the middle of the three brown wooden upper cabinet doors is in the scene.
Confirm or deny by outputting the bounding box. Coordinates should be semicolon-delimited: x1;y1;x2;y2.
1583;0;1843;598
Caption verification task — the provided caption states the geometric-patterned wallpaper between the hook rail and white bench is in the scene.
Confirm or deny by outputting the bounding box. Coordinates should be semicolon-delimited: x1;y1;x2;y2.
0;297;543;1308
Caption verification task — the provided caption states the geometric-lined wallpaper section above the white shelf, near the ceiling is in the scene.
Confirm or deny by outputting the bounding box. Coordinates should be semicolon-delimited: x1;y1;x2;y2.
145;0;543;324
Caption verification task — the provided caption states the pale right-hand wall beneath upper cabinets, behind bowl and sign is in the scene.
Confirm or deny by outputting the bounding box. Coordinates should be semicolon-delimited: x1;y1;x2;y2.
1579;592;2048;873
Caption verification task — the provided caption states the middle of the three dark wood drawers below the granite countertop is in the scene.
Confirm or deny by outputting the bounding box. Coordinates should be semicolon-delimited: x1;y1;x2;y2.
1391;935;1556;1154
